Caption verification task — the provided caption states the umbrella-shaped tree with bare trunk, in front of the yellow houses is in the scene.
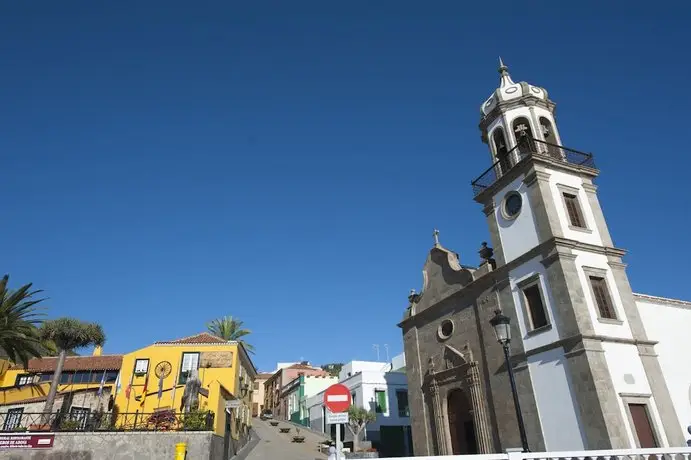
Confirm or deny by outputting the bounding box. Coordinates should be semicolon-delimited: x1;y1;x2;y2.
40;318;106;416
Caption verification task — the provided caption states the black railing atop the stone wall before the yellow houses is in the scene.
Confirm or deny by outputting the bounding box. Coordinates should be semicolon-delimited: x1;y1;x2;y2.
0;410;214;433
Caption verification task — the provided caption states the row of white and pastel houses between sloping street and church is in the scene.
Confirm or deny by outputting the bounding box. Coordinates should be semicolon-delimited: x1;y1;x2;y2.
253;354;413;457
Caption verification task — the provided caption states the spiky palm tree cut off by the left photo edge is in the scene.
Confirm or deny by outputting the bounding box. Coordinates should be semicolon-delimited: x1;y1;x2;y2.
0;275;44;366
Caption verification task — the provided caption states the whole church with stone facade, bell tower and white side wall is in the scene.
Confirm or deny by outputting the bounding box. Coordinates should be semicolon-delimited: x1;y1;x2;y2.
399;60;691;456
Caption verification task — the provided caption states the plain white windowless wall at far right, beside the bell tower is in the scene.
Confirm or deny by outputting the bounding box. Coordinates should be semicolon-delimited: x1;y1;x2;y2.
636;295;691;440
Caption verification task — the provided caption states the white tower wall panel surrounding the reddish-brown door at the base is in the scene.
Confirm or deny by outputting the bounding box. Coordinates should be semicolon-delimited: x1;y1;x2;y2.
602;342;668;447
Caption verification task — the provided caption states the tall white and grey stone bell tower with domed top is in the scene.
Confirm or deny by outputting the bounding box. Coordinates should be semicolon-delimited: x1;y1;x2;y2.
472;59;684;449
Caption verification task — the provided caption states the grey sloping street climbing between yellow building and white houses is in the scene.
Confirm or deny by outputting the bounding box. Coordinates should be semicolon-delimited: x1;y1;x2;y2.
245;419;326;460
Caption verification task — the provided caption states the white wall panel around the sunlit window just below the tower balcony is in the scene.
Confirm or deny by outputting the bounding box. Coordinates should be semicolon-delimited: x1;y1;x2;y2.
545;168;602;246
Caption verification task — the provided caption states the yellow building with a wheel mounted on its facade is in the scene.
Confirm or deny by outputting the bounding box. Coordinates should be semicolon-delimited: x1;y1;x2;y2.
115;332;257;439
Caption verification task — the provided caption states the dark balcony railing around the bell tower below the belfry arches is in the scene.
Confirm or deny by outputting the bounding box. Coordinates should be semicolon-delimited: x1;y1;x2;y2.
471;136;595;196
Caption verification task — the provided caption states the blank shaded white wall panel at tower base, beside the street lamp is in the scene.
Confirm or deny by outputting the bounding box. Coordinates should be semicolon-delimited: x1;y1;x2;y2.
528;347;586;451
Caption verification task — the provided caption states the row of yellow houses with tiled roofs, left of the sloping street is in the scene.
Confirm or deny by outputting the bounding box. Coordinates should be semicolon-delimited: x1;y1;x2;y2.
0;332;257;454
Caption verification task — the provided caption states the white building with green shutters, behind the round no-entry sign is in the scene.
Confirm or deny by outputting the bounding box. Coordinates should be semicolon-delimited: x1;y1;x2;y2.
305;354;412;456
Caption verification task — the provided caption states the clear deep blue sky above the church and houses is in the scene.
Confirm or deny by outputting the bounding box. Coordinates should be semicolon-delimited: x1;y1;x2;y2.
0;0;691;369
